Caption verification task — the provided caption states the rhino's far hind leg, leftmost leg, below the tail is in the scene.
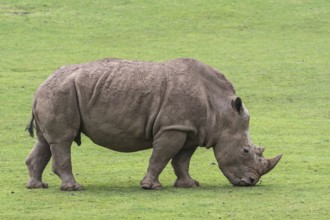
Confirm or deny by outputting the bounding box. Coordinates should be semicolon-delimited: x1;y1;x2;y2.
25;135;51;189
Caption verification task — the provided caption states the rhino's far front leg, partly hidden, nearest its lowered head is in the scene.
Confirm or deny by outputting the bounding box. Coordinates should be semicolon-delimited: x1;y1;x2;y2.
172;147;199;187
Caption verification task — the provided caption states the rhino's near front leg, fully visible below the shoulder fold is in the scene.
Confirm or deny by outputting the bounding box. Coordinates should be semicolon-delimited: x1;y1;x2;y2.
140;131;187;189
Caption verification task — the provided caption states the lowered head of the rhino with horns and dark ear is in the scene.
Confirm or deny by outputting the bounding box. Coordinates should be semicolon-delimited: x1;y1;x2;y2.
213;97;282;186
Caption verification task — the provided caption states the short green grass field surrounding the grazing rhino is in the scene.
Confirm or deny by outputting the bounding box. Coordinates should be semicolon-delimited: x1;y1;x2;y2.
0;0;330;219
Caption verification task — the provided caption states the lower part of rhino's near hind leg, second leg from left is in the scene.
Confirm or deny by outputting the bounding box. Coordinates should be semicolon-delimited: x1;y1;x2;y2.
50;142;82;191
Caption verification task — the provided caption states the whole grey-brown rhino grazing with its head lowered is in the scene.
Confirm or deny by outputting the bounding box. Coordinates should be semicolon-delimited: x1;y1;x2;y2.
26;59;281;190
